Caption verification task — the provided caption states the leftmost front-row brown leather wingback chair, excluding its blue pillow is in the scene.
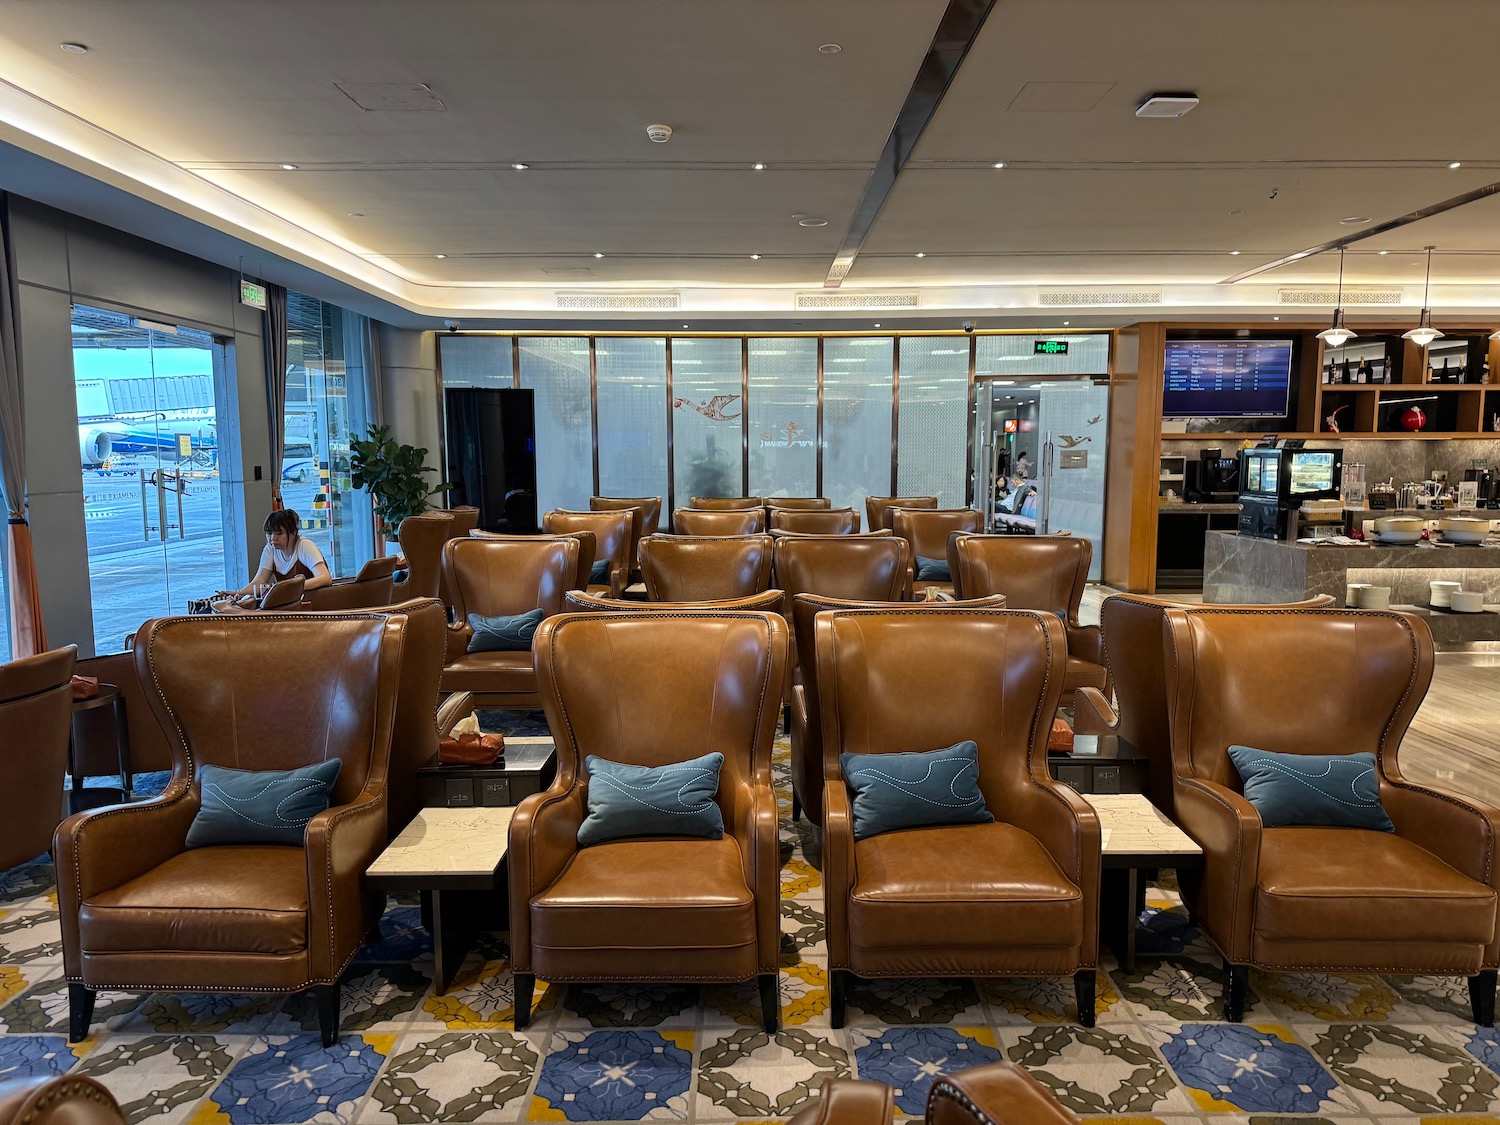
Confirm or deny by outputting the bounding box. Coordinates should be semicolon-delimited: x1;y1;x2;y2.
53;614;407;1046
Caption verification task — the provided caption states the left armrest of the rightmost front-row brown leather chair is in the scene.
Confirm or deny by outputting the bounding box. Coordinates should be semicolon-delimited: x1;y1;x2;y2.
1173;774;1260;965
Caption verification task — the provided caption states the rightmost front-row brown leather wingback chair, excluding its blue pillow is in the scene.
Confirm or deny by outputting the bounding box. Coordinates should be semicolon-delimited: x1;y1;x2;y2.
1166;606;1500;1028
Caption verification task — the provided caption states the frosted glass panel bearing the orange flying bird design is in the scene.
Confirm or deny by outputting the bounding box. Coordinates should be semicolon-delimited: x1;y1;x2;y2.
672;338;746;507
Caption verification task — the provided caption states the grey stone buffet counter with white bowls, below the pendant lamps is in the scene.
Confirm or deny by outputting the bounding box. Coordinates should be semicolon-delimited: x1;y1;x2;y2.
1203;531;1500;648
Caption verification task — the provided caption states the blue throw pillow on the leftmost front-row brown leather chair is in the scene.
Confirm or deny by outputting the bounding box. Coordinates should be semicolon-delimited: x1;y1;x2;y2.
186;758;344;848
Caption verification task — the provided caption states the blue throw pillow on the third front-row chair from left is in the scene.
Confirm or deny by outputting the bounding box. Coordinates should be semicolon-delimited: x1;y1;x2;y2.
839;740;995;840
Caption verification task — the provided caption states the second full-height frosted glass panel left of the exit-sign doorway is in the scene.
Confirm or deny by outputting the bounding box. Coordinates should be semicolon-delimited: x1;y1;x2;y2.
824;336;894;530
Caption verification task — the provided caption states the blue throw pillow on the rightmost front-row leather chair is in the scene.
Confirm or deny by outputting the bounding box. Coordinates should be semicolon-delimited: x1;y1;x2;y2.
1229;746;1395;833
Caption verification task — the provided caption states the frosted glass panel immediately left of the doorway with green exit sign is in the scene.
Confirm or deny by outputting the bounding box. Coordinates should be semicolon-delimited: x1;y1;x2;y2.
896;336;969;509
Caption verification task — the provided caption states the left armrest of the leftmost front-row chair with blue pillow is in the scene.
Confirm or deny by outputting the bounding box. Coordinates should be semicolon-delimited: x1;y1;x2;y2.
53;782;198;978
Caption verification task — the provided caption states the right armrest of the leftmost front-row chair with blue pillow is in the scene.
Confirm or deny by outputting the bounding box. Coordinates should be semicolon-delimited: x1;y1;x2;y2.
305;779;387;981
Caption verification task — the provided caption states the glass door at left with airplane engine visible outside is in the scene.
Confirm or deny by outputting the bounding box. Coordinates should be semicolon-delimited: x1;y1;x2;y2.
72;306;225;653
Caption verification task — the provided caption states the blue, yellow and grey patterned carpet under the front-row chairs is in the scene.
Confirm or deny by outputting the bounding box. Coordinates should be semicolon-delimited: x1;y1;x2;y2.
0;723;1500;1125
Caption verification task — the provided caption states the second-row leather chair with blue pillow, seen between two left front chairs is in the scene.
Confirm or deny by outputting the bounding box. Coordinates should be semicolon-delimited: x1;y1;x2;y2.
443;536;579;708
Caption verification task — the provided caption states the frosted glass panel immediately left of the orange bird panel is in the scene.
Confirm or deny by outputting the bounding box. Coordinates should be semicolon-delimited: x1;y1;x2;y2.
594;338;668;504
